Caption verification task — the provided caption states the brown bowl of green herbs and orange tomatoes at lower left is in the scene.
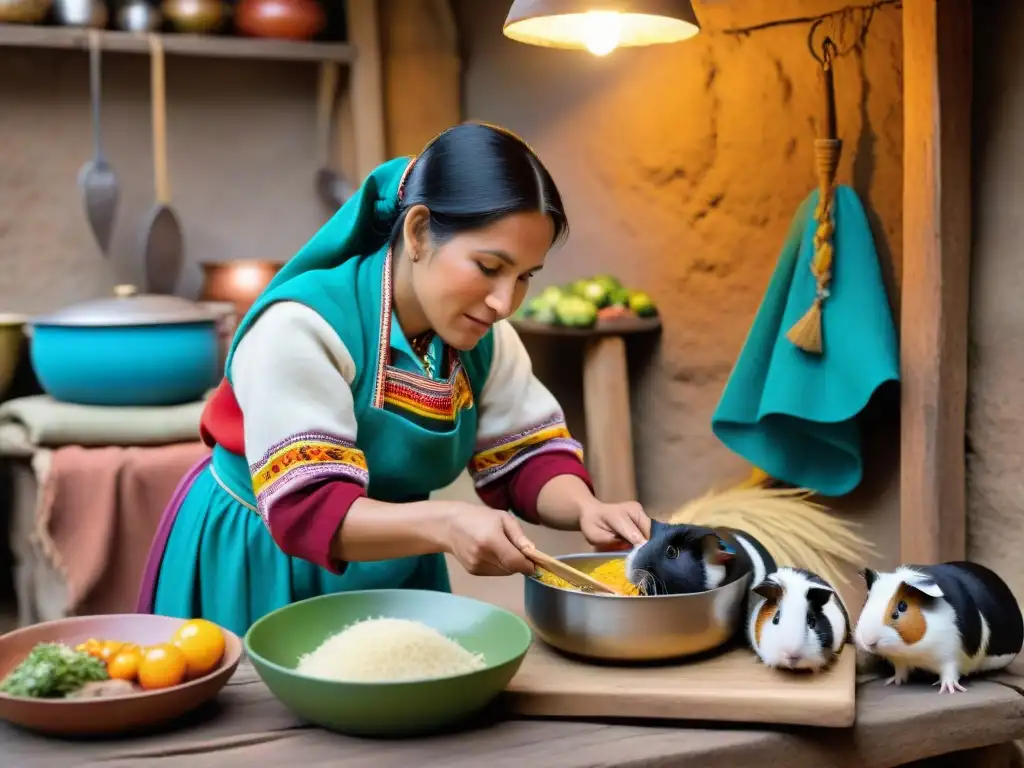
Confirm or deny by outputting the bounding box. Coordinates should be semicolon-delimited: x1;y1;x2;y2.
0;613;242;736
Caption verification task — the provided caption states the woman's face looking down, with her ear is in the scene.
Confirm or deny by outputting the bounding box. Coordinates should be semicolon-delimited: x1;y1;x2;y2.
406;209;555;350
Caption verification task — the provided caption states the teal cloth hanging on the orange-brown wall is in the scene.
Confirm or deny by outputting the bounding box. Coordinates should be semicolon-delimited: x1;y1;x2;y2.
712;185;899;497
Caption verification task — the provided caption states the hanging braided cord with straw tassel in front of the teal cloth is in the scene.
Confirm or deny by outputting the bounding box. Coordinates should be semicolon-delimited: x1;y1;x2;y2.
785;37;843;354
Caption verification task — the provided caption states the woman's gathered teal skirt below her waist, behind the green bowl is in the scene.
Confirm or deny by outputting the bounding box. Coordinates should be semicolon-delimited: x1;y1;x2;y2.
137;459;452;636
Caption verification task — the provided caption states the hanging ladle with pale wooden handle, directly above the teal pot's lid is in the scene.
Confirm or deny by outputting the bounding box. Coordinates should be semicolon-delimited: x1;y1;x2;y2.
142;35;184;294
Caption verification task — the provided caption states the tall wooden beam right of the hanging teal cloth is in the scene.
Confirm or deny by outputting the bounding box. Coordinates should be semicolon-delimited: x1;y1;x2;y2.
900;0;972;563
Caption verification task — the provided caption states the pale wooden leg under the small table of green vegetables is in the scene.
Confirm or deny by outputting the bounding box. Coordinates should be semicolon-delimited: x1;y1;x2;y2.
583;336;637;502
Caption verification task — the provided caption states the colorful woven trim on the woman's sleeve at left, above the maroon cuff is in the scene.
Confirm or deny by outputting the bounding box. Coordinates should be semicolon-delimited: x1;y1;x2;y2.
249;432;370;519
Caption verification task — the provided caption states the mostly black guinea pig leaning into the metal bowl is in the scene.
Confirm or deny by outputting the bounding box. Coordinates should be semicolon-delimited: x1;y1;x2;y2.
626;520;776;595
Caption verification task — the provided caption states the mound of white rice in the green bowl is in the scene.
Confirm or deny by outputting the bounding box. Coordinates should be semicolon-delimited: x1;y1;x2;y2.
297;618;485;683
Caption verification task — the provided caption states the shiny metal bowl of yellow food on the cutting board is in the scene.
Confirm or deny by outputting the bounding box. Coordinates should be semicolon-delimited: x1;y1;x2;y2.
525;553;751;662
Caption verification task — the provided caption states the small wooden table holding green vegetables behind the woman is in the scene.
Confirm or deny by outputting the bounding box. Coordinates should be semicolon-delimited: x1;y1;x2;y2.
512;317;662;502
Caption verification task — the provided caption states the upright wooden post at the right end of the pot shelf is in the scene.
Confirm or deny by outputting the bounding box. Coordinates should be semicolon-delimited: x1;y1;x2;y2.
345;0;387;179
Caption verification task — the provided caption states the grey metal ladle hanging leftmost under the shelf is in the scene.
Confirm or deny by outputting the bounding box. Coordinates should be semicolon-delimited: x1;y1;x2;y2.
78;29;120;256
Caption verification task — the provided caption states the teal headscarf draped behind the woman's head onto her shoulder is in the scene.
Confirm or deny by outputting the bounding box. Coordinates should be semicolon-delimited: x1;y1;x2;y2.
226;157;413;370
